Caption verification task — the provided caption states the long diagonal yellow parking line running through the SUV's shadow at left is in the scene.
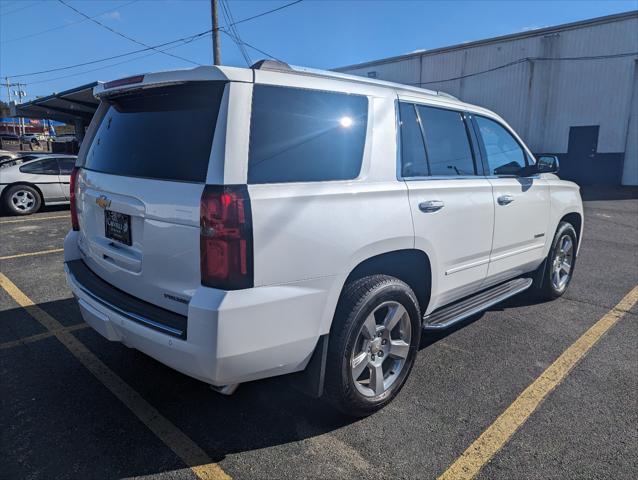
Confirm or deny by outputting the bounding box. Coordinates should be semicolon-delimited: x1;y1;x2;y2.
0;273;230;480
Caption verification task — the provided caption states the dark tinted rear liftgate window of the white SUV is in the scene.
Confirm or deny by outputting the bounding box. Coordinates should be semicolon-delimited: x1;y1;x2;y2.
84;82;225;182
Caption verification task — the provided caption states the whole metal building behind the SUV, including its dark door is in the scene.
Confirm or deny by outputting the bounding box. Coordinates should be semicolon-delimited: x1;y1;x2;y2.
335;11;638;185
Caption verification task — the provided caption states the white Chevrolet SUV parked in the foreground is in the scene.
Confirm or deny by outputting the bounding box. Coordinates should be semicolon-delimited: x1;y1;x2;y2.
64;62;583;415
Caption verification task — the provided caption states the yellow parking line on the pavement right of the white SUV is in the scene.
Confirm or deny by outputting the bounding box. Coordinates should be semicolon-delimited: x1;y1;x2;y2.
439;286;638;480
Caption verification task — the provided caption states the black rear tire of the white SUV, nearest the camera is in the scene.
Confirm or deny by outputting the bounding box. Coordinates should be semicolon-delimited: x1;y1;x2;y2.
324;275;421;417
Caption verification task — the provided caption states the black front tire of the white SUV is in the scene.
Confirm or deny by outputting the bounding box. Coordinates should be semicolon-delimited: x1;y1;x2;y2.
531;222;578;300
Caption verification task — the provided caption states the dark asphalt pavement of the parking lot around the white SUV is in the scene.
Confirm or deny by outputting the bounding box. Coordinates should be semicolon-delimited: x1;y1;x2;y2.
0;189;638;480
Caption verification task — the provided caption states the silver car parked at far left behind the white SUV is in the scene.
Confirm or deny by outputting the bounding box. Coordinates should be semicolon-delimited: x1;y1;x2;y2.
0;155;76;215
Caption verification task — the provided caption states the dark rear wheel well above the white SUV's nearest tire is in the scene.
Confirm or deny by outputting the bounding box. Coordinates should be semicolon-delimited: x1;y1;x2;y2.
346;249;432;313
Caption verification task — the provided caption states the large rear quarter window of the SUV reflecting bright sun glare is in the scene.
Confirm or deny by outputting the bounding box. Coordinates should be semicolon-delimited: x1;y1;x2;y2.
248;85;368;183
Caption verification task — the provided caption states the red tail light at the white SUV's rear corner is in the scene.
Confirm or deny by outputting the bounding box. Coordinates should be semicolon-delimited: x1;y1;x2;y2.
200;185;253;290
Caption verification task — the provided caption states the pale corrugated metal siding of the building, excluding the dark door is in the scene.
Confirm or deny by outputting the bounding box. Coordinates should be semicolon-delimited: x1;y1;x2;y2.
347;16;638;184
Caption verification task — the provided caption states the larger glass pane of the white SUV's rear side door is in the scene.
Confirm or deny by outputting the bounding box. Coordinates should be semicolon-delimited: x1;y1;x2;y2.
417;105;476;176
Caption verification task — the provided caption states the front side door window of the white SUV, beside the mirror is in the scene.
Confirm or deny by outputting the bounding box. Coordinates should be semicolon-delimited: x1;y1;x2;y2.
475;116;526;175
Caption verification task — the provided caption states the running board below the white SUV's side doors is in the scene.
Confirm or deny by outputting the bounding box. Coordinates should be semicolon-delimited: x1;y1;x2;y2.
423;278;532;330
